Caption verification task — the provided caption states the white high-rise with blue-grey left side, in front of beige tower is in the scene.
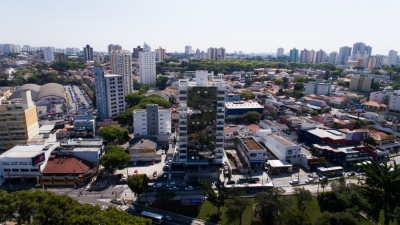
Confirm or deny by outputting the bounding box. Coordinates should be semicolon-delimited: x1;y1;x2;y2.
93;66;125;119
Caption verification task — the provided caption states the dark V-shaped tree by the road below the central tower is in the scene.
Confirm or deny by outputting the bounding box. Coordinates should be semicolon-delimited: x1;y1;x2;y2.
201;180;228;215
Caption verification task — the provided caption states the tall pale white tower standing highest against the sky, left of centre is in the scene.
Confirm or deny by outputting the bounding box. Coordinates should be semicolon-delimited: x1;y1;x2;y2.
139;43;157;85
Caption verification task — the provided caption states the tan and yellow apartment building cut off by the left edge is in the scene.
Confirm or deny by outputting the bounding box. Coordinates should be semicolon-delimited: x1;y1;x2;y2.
0;90;39;152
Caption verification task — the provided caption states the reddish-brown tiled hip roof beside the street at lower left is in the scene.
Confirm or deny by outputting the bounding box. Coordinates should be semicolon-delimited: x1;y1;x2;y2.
43;157;90;174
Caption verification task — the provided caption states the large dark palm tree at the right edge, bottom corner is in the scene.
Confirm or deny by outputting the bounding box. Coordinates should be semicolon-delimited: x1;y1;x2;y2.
360;160;400;225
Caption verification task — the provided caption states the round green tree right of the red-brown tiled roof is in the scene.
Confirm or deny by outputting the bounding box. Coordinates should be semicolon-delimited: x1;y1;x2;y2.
101;145;131;172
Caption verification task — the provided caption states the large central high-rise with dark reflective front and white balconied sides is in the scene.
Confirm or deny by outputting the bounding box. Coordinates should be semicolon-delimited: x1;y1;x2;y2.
177;71;226;165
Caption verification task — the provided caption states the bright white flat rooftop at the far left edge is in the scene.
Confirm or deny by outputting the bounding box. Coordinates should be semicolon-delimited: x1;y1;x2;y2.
0;145;52;158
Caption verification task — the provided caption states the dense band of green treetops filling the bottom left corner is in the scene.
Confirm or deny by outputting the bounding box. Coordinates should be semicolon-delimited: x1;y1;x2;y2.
0;190;152;225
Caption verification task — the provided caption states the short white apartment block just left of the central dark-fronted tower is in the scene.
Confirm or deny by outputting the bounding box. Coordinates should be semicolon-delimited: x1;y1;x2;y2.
133;104;171;135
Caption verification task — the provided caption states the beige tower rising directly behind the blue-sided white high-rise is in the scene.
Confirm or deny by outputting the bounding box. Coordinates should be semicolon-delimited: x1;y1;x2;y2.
110;50;133;96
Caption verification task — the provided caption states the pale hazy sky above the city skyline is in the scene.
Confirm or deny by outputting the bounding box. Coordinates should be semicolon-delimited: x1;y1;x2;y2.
0;0;400;55
